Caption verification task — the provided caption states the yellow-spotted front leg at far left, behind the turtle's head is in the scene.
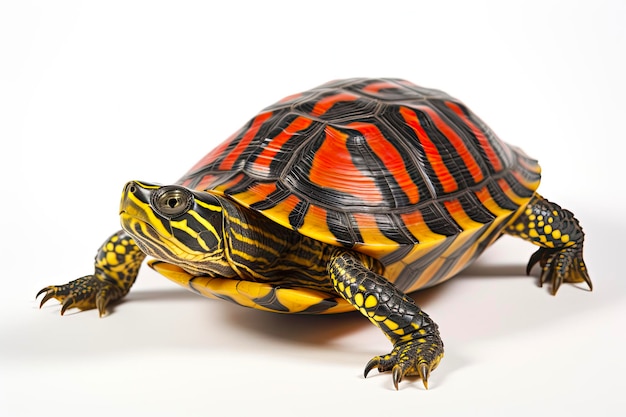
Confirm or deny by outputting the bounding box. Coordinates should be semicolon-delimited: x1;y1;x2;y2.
37;230;146;317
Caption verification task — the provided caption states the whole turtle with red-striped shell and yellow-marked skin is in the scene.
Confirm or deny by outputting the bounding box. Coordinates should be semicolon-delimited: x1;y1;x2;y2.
37;78;592;389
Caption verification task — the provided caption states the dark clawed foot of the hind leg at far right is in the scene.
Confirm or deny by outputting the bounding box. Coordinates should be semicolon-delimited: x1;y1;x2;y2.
526;246;593;295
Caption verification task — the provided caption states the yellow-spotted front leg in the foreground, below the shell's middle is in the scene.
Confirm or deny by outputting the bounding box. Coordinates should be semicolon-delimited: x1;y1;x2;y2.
328;252;443;389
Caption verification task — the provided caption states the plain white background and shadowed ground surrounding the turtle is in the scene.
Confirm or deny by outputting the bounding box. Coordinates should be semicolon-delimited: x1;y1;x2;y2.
0;0;626;416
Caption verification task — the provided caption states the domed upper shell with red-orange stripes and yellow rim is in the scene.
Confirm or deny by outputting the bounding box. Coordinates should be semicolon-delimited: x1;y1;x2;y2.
179;78;540;291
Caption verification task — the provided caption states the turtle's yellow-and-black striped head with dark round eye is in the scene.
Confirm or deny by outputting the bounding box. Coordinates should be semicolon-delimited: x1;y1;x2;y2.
120;181;232;276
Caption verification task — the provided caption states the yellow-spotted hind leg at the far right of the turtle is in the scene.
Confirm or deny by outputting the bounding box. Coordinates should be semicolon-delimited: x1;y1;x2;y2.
506;194;593;295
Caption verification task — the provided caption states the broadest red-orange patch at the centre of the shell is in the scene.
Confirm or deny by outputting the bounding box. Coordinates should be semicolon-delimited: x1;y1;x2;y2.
309;126;383;203
